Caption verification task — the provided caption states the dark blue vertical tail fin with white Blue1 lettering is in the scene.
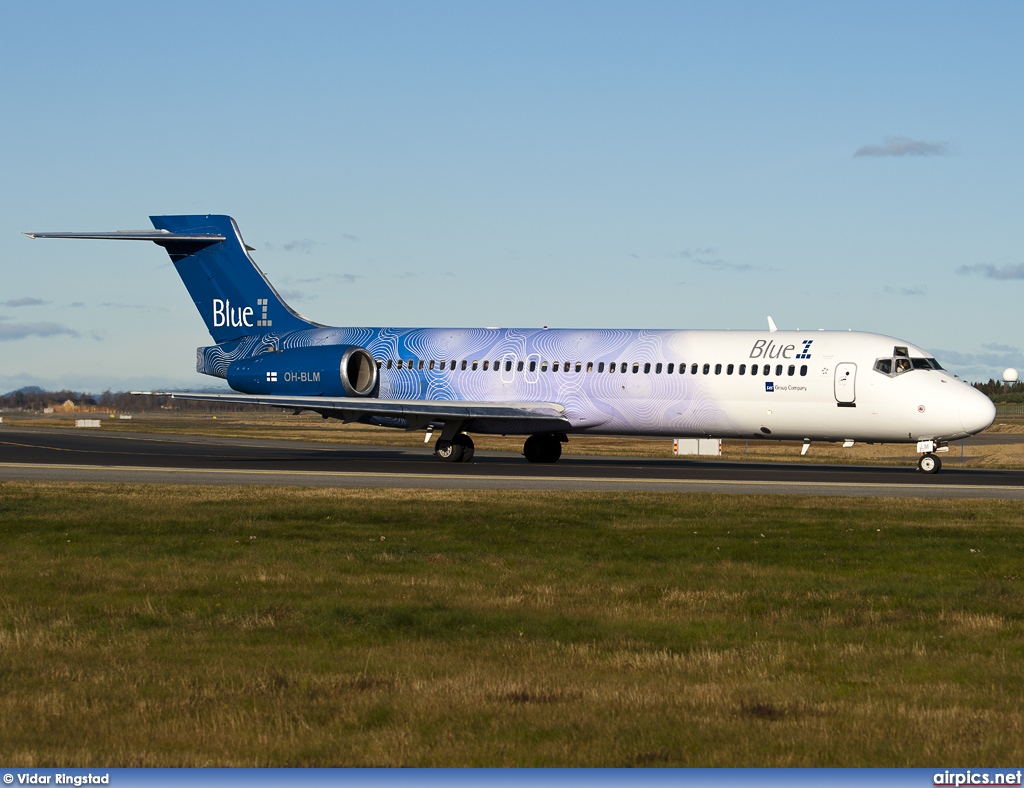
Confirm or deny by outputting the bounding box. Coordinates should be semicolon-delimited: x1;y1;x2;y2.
150;215;318;344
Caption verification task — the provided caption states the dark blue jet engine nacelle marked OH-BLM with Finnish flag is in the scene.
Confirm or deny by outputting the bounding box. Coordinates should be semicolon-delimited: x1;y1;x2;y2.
227;345;378;397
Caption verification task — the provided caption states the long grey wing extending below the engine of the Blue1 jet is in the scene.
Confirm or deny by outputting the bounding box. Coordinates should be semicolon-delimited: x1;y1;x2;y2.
132;391;570;434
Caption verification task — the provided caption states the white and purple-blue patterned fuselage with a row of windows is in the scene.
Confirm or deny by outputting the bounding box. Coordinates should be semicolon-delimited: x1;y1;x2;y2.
201;327;995;442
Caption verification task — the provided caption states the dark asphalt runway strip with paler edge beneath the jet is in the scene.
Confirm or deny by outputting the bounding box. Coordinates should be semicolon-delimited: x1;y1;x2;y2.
0;426;1024;500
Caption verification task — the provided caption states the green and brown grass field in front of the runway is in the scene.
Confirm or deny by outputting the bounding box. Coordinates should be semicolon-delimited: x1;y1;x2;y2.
0;483;1024;767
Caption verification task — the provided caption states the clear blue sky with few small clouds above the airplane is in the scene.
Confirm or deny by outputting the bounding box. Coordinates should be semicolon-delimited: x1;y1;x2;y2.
0;2;1024;391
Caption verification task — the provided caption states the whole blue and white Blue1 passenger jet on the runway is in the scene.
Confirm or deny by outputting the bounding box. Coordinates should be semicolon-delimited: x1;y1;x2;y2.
25;215;995;474
